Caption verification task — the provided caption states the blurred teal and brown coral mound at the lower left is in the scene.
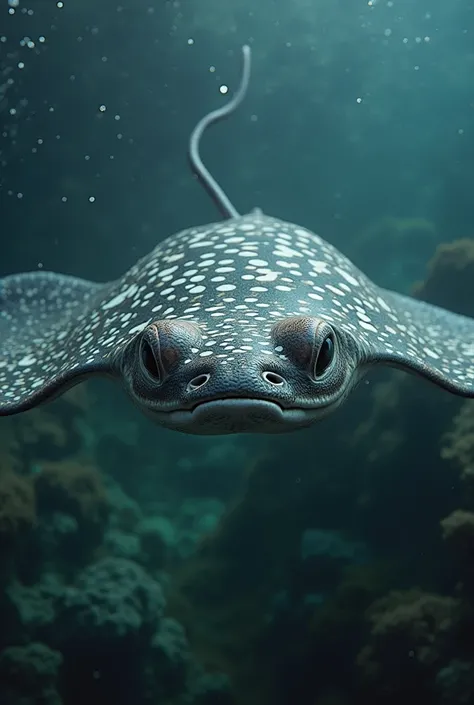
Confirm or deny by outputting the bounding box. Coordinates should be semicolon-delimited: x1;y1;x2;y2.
0;384;239;705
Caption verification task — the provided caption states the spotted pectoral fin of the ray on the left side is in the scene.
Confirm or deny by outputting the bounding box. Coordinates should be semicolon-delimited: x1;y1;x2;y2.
0;272;109;416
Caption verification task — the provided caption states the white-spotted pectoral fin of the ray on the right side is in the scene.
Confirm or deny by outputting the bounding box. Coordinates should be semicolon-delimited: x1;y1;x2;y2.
362;289;474;397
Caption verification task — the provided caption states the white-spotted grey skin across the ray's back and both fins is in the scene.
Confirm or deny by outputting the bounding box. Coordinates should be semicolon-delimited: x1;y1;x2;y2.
0;212;474;428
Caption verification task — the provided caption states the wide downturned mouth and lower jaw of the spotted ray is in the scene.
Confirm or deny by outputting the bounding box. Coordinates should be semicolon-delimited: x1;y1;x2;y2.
152;397;322;435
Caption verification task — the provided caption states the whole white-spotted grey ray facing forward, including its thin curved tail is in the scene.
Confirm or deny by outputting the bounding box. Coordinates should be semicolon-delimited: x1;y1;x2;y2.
0;47;474;434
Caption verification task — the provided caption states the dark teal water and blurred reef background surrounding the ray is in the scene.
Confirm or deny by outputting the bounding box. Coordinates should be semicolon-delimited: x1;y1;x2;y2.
0;0;474;705
